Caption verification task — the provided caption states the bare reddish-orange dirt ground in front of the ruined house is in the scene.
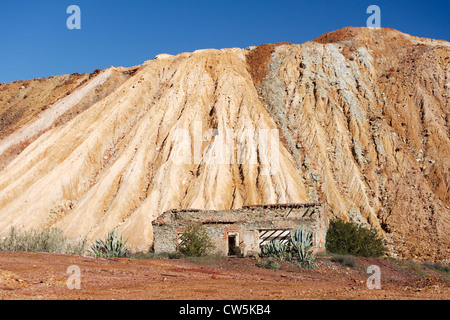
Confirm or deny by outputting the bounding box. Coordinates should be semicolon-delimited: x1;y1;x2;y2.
0;252;450;300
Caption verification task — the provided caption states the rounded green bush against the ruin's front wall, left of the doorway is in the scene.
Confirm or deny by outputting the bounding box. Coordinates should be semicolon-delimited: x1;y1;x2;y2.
178;223;214;257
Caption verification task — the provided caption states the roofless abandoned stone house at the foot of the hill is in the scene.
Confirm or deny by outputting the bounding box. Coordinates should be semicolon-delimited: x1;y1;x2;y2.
153;203;328;256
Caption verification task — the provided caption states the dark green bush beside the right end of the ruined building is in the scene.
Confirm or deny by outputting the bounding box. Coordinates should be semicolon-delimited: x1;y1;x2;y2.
325;219;386;257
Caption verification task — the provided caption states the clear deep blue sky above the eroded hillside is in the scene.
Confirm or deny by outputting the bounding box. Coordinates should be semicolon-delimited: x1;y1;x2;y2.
0;0;450;82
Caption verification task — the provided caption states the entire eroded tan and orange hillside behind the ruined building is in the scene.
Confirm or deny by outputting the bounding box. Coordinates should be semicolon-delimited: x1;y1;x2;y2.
0;28;450;260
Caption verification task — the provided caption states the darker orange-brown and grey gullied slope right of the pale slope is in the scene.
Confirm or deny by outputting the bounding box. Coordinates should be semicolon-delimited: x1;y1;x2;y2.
249;28;450;258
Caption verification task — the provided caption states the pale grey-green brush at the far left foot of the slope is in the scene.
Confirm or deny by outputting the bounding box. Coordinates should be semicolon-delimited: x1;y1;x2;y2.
0;227;87;255
